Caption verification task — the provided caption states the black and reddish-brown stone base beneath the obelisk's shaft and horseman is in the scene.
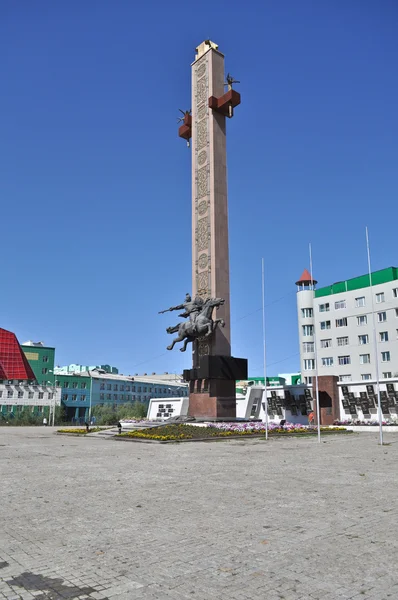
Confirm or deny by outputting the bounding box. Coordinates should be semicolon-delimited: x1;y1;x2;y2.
184;356;247;421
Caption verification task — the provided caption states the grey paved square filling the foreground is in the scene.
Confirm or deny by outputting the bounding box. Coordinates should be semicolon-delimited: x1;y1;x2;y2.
0;427;398;600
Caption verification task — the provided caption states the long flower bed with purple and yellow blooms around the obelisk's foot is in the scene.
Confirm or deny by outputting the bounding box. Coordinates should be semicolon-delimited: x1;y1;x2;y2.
118;423;347;442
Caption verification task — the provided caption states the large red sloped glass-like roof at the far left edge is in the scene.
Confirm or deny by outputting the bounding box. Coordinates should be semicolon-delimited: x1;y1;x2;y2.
0;327;36;380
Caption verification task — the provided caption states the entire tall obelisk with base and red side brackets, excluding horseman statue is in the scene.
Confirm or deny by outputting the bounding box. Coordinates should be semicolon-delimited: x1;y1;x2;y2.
179;40;247;419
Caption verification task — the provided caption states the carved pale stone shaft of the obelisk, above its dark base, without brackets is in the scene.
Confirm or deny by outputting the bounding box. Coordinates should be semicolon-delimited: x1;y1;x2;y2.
191;40;231;362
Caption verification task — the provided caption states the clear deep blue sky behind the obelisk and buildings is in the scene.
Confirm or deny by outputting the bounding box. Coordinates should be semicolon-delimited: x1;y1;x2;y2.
0;0;398;375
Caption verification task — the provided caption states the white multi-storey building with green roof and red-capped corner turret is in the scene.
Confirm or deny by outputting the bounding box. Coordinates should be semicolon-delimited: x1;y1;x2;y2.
297;267;398;384
